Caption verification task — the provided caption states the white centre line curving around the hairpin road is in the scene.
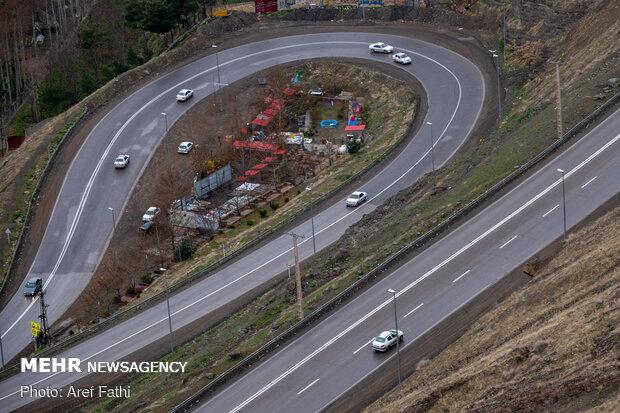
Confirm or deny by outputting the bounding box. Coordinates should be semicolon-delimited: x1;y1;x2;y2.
0;41;462;342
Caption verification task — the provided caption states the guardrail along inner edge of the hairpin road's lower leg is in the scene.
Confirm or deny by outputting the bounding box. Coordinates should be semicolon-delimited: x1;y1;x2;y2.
0;95;420;380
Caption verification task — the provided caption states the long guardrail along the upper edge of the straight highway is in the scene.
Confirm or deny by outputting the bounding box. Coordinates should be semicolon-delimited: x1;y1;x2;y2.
171;93;620;413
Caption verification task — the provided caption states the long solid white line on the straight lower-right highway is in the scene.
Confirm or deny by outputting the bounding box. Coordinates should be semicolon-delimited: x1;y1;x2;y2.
223;134;620;413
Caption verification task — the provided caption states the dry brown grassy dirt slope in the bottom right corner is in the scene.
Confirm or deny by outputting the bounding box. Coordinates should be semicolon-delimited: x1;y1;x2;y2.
366;207;620;412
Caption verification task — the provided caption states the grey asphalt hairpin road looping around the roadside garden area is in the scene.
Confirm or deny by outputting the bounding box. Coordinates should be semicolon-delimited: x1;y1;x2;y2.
0;33;485;411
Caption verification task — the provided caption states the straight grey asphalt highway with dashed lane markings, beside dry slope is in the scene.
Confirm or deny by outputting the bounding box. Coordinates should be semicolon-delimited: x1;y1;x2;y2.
196;111;620;413
